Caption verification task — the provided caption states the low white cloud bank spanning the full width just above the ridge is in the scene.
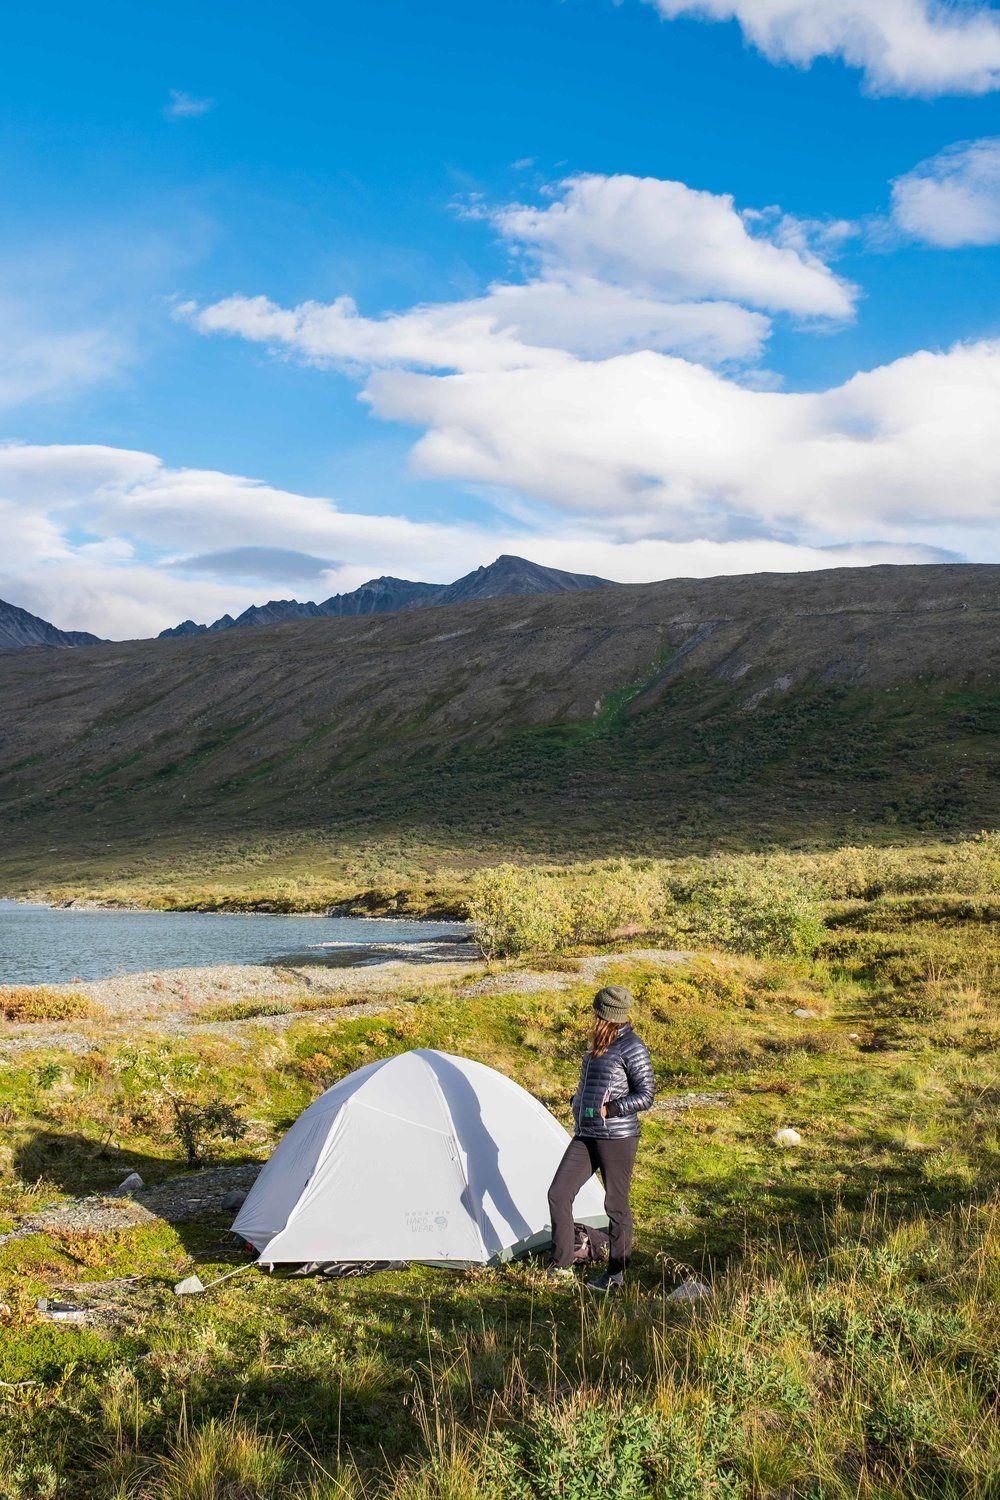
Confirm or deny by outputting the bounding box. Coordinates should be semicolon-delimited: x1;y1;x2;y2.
0;331;1000;636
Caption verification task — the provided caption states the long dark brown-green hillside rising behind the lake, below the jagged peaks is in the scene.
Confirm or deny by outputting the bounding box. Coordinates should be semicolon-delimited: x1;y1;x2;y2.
0;567;1000;905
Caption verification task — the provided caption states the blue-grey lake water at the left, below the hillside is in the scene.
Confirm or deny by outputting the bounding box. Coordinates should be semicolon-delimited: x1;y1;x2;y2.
0;900;468;984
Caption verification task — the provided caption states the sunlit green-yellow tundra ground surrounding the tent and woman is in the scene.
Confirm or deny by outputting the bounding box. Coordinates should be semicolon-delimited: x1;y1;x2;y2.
0;834;1000;1500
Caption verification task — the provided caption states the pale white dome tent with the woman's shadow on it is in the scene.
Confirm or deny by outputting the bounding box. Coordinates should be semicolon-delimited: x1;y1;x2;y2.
232;1049;607;1266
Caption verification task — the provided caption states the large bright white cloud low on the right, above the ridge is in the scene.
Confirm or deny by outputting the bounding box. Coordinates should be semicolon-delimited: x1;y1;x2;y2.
367;344;1000;545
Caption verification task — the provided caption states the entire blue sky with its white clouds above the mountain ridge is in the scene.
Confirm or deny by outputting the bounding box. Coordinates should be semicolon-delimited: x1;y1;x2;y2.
0;0;1000;635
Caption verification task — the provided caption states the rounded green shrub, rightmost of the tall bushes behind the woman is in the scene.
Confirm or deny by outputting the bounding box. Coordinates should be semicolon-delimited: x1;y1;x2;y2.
690;861;823;959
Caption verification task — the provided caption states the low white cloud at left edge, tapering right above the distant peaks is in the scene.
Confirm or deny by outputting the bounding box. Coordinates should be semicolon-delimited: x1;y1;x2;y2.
0;444;499;636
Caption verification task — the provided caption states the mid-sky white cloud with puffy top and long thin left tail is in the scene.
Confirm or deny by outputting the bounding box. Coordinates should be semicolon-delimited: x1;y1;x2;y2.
178;174;856;384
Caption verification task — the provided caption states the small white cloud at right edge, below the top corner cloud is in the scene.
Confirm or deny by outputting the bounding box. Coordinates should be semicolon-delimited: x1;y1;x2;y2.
892;135;1000;249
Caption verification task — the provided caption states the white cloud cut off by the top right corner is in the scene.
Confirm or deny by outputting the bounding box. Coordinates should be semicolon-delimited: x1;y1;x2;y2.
651;0;1000;98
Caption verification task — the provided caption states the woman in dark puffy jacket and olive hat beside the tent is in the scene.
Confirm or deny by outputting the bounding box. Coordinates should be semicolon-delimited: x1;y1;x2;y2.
549;984;654;1292
